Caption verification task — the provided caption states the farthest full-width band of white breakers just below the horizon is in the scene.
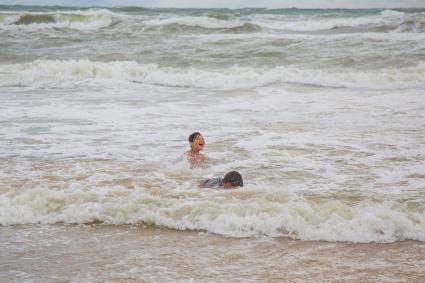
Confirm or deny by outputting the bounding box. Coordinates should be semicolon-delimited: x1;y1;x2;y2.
0;8;425;33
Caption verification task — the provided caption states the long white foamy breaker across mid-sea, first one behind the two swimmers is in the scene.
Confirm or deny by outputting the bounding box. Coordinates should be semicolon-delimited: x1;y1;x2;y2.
0;60;425;89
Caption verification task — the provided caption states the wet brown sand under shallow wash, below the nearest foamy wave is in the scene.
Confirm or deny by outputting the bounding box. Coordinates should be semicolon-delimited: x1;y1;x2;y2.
0;224;425;282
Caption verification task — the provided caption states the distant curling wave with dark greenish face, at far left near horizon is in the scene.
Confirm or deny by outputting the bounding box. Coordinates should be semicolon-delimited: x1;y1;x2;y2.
0;10;114;30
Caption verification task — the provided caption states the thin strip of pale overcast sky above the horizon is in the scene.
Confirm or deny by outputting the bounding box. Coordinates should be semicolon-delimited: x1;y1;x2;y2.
0;0;425;8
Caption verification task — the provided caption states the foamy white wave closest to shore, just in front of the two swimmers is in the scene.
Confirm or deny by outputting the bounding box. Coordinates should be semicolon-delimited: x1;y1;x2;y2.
0;188;425;242
